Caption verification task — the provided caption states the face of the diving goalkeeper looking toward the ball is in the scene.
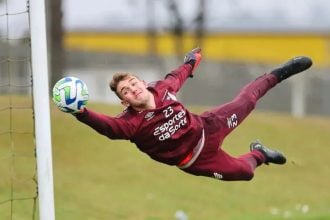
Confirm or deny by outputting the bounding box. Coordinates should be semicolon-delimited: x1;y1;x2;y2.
117;76;153;110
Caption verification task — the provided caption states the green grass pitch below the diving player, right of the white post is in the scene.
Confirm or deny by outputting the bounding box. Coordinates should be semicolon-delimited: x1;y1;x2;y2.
0;99;330;220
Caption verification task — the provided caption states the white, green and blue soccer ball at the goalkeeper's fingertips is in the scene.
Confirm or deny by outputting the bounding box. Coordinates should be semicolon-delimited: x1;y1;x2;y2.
53;76;89;113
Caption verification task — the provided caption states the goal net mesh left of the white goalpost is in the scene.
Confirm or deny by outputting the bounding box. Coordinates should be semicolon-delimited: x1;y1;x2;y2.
0;0;38;219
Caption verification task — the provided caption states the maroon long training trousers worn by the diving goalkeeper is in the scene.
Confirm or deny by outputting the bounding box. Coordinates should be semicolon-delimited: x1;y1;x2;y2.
182;74;277;180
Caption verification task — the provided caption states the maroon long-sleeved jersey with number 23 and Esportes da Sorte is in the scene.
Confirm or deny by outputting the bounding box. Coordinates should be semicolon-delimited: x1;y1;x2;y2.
77;64;203;165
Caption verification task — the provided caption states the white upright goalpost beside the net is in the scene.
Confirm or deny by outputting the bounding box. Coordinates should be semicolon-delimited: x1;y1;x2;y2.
30;0;55;220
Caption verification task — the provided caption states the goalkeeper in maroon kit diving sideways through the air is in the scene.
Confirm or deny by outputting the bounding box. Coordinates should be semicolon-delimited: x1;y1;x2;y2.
75;48;312;181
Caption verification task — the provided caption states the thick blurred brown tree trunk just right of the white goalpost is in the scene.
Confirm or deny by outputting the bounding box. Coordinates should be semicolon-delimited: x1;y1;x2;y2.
46;0;65;88
